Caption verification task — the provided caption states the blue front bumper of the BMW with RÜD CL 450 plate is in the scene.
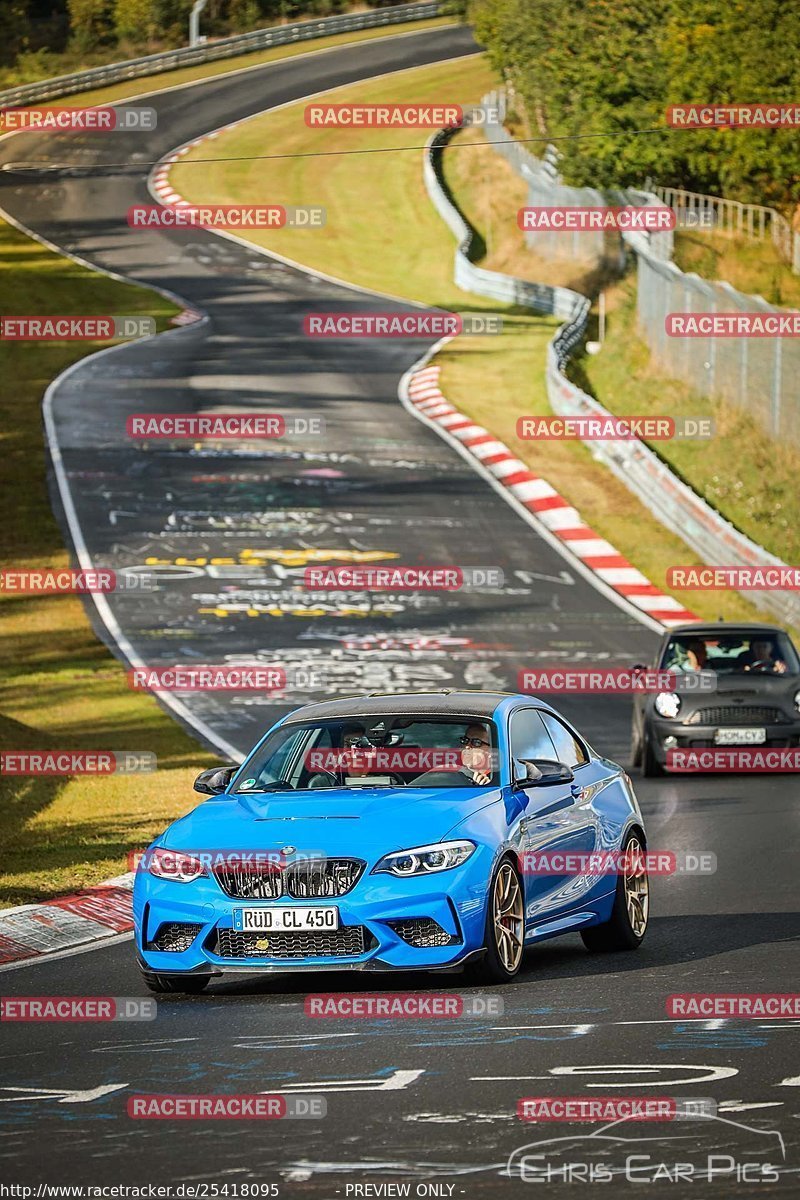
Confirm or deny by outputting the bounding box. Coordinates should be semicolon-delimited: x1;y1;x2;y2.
133;847;492;976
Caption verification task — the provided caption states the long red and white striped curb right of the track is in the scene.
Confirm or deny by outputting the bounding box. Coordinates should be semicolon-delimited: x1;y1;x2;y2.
408;366;698;626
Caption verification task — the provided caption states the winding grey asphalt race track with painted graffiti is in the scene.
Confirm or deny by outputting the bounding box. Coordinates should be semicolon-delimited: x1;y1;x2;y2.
0;21;800;1198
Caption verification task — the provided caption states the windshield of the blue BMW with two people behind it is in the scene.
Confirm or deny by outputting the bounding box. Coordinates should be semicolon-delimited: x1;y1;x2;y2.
234;714;499;794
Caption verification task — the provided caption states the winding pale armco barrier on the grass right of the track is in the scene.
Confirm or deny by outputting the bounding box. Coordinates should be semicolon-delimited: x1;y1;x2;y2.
423;110;800;626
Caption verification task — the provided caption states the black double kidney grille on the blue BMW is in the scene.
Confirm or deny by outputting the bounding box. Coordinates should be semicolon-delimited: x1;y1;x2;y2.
213;858;365;900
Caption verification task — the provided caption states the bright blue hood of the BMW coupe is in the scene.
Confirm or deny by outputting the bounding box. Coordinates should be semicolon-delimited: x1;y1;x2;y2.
158;787;500;858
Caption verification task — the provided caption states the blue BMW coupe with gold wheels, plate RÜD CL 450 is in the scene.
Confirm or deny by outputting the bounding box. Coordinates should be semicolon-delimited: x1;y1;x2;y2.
133;691;649;992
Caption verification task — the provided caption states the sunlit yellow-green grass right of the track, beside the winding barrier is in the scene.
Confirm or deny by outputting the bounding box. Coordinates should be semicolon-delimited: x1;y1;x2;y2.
170;72;786;638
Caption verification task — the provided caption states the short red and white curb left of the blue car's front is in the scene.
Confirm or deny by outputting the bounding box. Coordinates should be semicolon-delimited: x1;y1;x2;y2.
0;871;133;964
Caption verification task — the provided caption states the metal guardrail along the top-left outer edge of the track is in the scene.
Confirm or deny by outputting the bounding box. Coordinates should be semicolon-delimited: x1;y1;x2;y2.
0;0;445;108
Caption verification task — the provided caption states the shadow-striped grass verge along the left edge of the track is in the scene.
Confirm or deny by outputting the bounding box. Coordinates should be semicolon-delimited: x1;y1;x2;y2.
0;222;215;905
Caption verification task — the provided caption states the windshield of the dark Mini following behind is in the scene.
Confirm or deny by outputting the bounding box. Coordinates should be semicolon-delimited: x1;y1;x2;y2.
661;629;800;674
